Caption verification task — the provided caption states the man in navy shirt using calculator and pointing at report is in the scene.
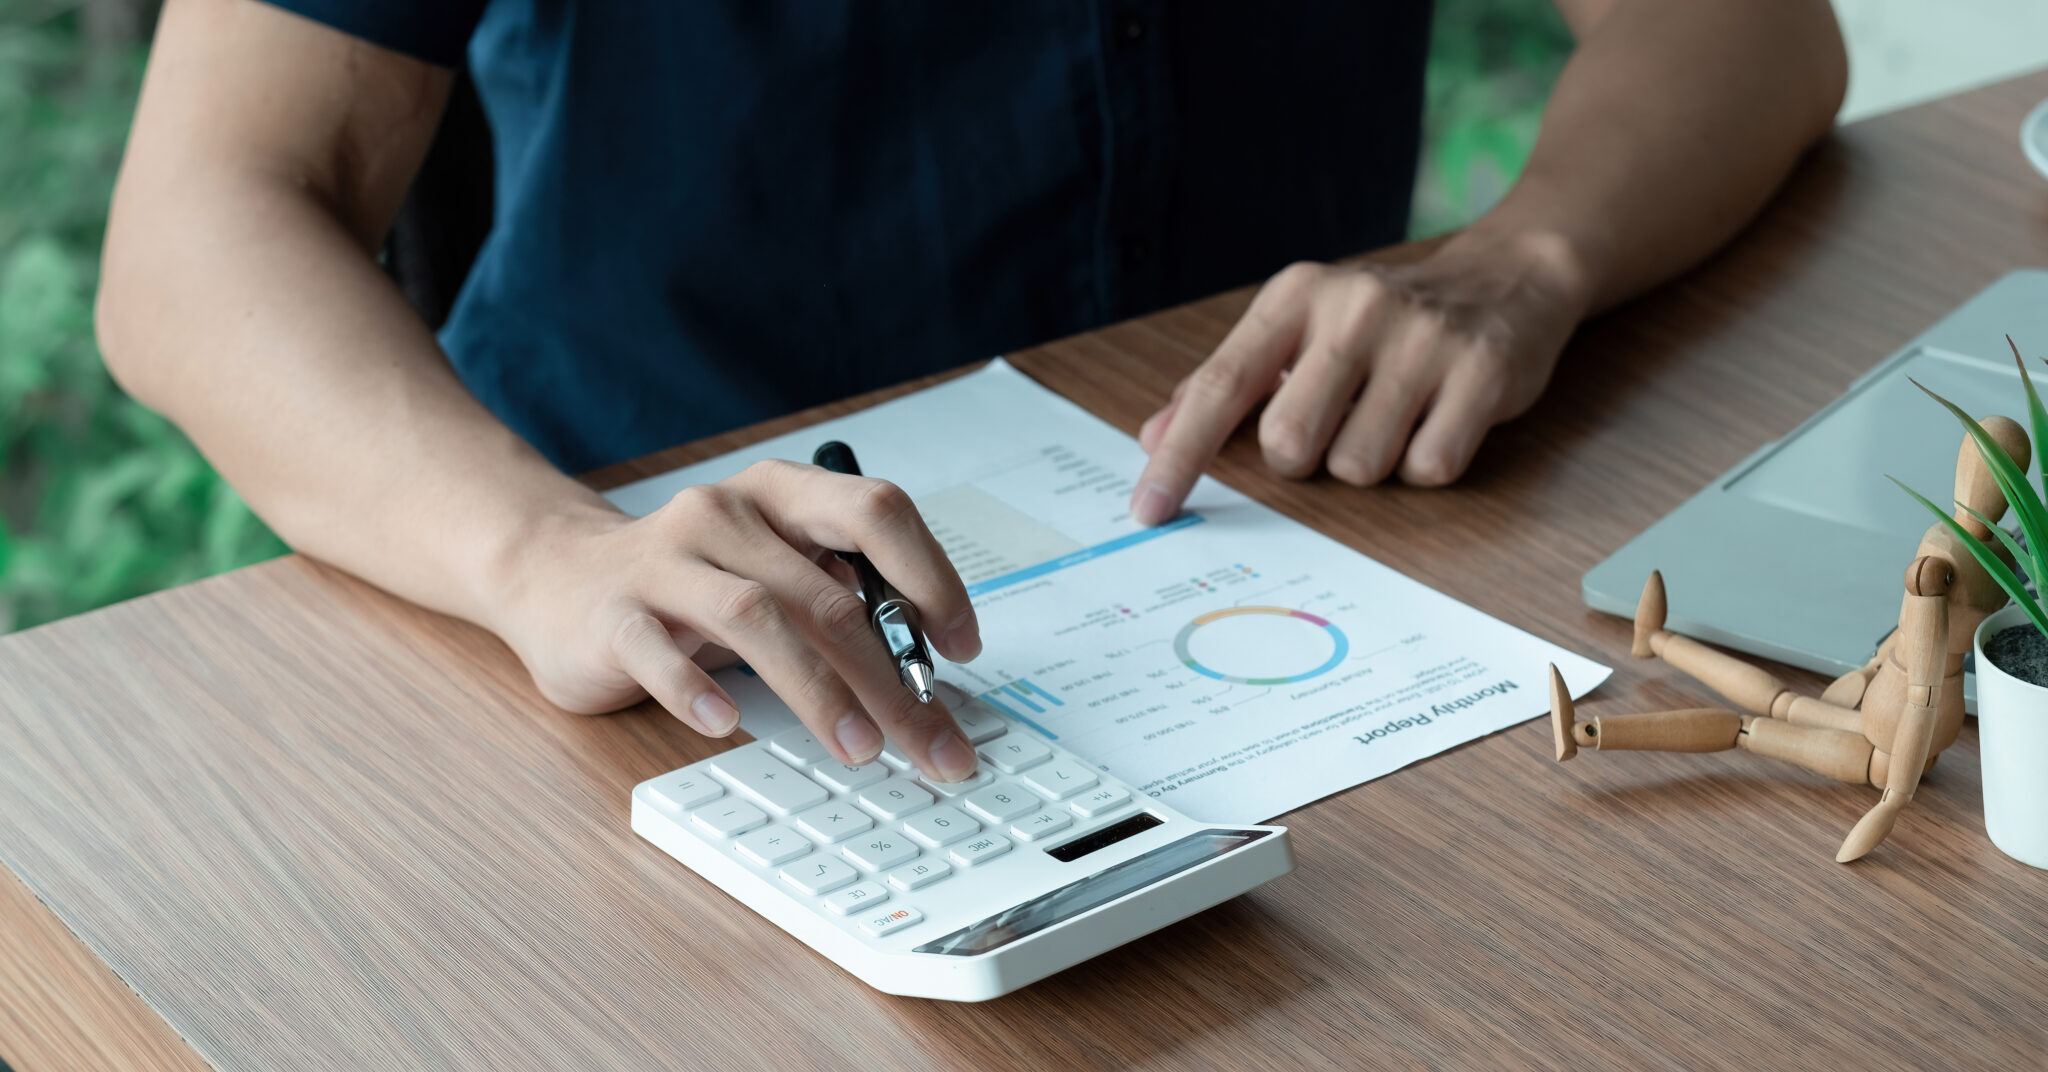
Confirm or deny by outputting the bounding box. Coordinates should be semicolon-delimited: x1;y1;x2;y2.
98;0;1845;779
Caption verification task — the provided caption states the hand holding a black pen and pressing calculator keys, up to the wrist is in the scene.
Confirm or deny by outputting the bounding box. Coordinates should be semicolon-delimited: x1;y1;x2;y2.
492;461;981;781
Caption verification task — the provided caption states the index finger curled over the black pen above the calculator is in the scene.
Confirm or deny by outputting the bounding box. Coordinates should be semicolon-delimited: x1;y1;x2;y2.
739;461;981;662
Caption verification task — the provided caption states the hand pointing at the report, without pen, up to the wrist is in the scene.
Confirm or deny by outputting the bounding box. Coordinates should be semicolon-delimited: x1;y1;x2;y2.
1130;232;1591;525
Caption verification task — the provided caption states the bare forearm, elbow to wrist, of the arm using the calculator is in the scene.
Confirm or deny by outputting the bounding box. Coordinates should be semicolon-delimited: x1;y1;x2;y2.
100;176;606;625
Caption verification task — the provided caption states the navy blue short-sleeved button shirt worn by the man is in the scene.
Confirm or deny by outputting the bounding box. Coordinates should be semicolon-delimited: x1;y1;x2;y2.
274;0;1430;471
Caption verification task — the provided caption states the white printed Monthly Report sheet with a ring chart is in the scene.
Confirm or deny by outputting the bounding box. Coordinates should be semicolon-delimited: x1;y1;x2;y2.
610;361;1610;822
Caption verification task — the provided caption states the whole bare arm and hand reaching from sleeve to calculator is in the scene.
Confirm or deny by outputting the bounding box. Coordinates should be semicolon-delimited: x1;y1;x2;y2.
98;0;981;781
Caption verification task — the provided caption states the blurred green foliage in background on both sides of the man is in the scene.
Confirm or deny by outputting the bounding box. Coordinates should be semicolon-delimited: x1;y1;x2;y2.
0;0;1571;631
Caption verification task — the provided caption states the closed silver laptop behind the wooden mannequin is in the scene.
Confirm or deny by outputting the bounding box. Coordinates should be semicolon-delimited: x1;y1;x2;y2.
1583;269;2048;688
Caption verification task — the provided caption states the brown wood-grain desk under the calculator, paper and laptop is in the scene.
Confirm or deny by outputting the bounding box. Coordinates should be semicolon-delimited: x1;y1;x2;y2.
12;74;2048;1072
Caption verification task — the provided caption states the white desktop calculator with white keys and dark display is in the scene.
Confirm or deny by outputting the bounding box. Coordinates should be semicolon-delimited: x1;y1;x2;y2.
633;703;1294;1000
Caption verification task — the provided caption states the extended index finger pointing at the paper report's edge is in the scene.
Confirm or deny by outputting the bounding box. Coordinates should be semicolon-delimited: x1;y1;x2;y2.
1130;264;1319;525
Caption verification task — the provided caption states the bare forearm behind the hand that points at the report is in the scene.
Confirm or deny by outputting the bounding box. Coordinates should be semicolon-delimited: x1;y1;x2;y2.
1460;0;1847;312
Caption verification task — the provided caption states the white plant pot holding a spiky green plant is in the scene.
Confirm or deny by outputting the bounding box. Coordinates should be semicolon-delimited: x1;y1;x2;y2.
1976;607;2048;869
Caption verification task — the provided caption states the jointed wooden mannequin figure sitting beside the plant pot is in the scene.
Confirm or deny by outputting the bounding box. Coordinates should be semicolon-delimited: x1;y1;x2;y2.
1550;416;2032;863
